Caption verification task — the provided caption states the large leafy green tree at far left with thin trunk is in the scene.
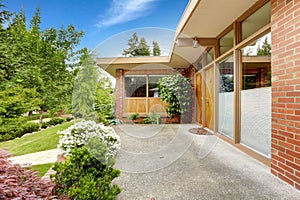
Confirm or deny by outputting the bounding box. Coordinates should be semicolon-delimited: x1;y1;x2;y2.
0;6;83;128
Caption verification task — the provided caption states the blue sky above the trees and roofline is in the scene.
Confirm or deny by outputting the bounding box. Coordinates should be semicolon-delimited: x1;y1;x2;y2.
3;0;188;57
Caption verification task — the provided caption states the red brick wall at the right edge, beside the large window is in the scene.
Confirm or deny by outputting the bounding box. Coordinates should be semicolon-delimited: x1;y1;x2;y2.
271;0;300;189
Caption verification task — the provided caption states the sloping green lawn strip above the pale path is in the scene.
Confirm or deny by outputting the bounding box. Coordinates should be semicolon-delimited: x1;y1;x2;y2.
0;121;74;156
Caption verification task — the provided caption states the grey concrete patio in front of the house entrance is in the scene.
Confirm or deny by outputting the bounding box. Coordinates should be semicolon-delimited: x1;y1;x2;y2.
115;124;300;200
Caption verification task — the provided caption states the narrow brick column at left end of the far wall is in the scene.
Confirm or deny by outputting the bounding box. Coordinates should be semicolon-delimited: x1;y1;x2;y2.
116;69;124;119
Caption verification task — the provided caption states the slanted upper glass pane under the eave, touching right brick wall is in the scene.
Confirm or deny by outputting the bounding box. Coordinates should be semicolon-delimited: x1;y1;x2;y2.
242;2;271;40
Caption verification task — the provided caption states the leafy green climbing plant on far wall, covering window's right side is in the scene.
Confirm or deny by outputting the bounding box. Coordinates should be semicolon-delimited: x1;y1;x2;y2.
158;74;192;118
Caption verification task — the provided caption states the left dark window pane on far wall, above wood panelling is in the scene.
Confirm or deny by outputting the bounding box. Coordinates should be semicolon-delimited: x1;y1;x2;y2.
125;76;147;97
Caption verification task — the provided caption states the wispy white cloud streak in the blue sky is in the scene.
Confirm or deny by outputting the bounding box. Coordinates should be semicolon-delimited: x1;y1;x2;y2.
97;0;157;28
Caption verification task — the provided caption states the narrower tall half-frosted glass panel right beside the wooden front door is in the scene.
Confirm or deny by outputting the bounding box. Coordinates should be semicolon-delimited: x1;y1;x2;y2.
218;55;234;138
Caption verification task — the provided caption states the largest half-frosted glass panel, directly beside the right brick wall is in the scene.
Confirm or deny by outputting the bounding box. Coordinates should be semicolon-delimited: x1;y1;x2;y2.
240;34;272;156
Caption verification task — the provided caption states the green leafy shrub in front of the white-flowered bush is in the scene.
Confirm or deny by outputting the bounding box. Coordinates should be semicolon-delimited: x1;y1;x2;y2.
53;137;121;200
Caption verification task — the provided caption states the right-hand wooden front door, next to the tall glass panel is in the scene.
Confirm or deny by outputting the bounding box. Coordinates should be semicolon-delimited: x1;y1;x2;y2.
205;67;215;130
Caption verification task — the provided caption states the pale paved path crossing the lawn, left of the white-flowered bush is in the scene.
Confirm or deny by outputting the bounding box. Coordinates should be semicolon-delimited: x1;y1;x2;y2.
9;149;61;165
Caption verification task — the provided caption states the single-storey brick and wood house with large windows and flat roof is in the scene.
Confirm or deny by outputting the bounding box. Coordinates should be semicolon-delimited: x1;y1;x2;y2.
97;0;300;189
